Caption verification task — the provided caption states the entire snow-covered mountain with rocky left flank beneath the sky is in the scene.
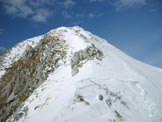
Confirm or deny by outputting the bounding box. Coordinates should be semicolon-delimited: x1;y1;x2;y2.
0;26;162;122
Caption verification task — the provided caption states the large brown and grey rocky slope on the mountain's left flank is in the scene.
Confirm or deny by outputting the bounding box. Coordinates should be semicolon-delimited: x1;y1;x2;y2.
0;34;66;122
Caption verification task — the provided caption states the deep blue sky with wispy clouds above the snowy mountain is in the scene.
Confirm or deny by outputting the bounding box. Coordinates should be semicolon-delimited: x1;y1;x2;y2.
0;0;162;67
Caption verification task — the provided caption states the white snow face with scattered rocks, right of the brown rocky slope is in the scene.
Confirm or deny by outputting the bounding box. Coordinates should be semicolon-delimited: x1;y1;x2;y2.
2;27;162;122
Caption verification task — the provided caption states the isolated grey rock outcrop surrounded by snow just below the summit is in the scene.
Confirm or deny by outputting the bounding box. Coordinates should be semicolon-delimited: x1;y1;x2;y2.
71;44;103;76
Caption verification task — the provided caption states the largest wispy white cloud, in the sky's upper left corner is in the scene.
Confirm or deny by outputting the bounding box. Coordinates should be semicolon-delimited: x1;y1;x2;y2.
0;0;54;22
